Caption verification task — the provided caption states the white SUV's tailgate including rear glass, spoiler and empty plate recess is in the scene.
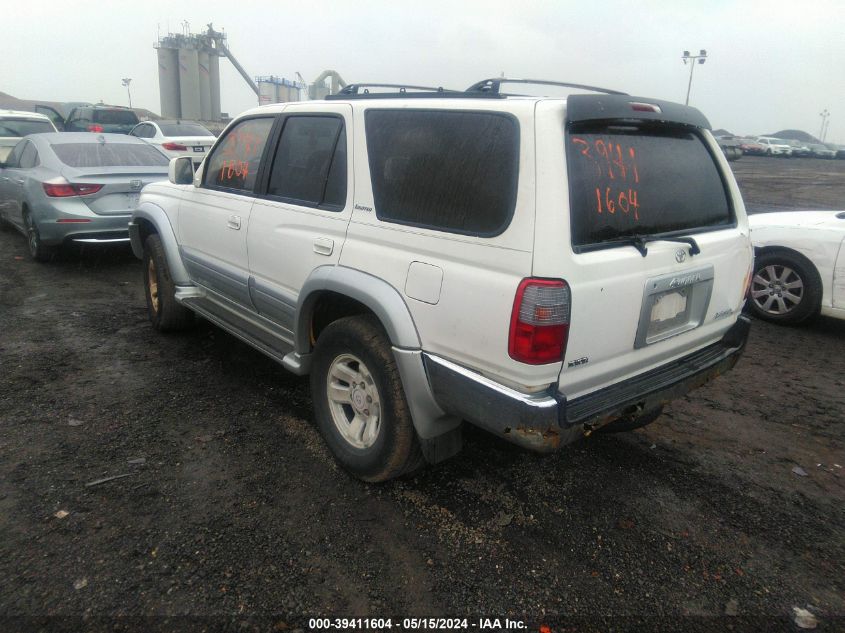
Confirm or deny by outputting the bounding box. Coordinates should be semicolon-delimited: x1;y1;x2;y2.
534;95;752;399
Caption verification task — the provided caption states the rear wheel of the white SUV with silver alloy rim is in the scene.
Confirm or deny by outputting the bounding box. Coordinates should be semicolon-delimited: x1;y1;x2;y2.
311;315;422;482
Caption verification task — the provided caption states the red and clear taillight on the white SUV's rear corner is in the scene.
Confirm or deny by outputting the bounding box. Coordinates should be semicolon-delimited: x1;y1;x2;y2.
508;279;572;365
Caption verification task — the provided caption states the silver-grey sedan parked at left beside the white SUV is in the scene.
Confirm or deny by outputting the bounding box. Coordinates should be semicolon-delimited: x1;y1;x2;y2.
0;132;168;261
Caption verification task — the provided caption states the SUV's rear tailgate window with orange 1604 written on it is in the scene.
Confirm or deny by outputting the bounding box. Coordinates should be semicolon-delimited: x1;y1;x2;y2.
565;125;735;251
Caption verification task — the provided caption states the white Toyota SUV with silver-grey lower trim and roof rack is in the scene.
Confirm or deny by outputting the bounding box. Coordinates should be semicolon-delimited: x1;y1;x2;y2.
130;80;752;481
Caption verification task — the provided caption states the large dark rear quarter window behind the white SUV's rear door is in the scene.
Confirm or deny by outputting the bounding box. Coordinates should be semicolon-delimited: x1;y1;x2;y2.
366;110;519;236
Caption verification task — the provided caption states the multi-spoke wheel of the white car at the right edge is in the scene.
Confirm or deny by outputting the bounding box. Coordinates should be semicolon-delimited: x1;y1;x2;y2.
748;251;822;325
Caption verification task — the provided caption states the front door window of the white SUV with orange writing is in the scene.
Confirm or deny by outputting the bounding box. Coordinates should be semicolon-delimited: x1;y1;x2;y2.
203;117;274;192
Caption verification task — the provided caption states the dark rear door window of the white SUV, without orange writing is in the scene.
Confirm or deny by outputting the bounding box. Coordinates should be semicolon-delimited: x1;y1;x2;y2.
267;116;346;209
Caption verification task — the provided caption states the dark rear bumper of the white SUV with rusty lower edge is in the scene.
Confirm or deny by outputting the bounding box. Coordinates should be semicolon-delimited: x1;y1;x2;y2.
423;316;750;452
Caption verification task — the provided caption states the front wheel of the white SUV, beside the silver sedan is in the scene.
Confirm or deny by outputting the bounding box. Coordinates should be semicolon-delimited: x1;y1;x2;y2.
144;233;194;332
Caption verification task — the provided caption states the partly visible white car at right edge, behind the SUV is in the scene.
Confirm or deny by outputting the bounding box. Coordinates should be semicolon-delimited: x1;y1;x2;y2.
748;211;845;323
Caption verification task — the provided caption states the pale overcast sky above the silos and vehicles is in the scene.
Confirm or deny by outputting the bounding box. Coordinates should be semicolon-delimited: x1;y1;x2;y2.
0;0;845;144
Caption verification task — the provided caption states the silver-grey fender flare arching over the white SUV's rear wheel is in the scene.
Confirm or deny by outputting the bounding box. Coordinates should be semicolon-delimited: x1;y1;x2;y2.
293;266;421;354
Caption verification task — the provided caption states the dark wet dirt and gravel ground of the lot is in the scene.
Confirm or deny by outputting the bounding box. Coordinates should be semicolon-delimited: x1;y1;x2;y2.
0;158;845;632
